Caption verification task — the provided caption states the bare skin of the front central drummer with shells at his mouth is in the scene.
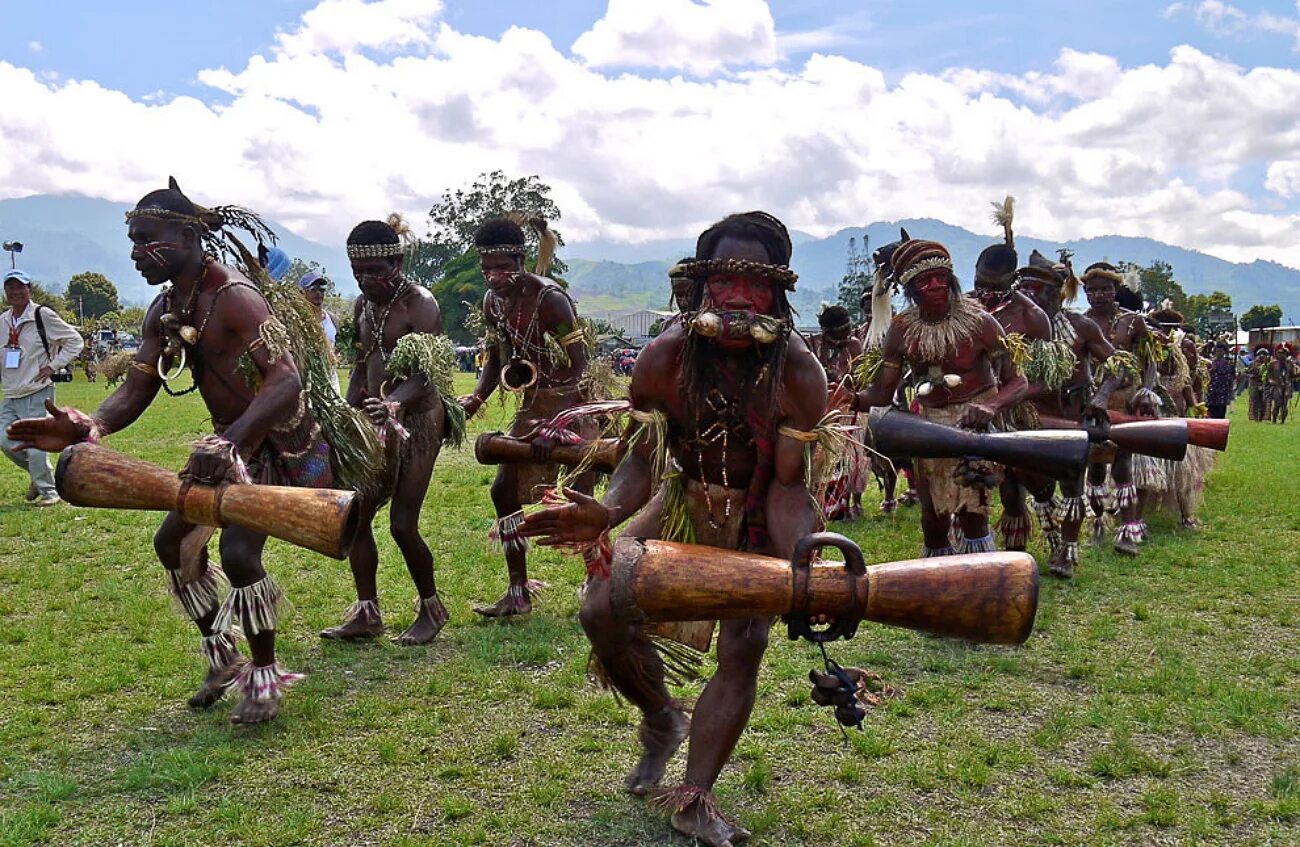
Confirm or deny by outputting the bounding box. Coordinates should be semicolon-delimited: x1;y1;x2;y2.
524;238;827;844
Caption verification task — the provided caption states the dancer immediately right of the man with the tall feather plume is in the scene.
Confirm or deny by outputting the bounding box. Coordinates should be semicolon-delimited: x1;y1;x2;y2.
1019;251;1118;579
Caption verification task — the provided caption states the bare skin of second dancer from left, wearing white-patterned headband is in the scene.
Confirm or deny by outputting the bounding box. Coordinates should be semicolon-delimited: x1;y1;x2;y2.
321;256;446;646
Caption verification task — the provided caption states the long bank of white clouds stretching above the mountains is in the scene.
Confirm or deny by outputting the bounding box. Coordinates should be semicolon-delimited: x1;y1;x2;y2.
0;0;1300;266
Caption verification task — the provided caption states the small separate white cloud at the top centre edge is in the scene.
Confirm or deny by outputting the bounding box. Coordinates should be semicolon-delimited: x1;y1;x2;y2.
573;0;779;77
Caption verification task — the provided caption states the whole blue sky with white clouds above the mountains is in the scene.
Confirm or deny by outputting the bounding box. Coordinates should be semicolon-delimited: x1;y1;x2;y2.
0;0;1300;268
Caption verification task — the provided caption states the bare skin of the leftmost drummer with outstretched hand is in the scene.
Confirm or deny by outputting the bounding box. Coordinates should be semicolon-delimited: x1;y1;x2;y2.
9;217;302;724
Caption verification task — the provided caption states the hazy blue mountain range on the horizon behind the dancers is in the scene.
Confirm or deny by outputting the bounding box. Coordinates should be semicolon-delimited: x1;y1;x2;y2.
0;195;1300;323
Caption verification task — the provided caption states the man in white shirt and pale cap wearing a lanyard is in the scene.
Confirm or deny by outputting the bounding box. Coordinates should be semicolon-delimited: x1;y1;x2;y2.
0;269;86;505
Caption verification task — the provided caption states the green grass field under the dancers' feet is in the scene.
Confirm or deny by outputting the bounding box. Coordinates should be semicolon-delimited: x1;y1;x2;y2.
0;382;1300;847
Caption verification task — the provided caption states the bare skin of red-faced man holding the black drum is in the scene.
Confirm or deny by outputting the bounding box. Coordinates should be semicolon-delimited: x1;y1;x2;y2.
855;269;1028;548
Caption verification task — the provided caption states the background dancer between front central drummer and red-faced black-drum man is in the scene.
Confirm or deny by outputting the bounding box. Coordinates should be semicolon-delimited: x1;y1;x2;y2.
809;305;866;521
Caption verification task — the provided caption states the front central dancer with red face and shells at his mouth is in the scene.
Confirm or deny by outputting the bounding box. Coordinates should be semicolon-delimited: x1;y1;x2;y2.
524;212;827;847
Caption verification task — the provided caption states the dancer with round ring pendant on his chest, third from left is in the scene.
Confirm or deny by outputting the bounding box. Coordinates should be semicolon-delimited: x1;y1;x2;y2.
460;218;594;617
